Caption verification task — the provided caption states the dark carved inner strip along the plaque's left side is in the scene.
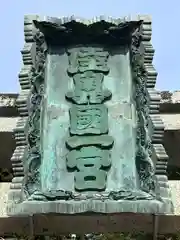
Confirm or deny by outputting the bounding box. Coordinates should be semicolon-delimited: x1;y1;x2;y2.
24;31;47;196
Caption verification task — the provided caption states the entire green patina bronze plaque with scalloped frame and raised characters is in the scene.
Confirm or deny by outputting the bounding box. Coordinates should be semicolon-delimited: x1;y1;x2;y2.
7;17;172;214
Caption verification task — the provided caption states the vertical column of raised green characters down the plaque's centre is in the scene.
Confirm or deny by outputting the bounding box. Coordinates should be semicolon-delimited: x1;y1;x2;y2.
66;47;111;191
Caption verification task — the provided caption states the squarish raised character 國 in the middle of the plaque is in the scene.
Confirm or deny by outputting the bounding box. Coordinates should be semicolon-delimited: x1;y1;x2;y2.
70;105;108;135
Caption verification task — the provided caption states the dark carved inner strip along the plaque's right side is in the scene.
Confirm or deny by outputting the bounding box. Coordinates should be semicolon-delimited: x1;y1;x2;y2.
131;25;155;192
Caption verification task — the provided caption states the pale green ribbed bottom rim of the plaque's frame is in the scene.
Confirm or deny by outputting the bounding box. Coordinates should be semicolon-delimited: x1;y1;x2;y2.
7;199;174;216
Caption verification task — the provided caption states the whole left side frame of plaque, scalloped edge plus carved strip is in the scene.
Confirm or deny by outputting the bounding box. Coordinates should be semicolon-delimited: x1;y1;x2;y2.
9;16;46;202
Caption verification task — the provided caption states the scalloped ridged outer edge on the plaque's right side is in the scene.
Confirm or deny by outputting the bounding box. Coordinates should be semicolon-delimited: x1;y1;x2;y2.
142;20;171;200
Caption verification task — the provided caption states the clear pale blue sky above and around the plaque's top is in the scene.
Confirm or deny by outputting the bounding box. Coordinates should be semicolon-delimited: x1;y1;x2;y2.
0;0;180;92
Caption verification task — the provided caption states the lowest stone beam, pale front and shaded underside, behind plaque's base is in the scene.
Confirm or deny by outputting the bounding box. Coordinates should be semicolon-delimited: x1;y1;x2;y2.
0;181;180;236
